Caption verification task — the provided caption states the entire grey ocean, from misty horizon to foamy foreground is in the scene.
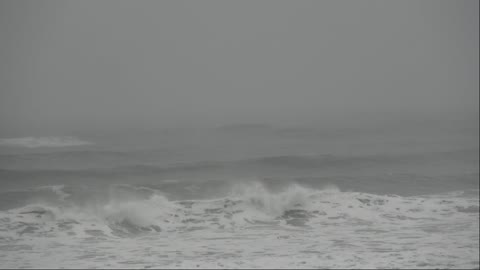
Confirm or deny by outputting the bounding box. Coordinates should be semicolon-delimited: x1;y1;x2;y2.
0;125;479;269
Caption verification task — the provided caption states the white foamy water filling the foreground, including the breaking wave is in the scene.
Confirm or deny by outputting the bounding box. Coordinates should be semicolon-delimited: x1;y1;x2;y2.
0;182;479;268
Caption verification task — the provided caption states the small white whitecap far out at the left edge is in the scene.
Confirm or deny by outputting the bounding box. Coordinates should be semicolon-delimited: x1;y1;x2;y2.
0;136;92;148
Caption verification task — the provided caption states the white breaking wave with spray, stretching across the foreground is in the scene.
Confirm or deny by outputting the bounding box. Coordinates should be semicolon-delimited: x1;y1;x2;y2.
0;183;479;239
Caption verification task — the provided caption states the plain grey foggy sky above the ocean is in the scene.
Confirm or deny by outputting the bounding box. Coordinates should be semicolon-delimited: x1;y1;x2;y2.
0;0;479;134
